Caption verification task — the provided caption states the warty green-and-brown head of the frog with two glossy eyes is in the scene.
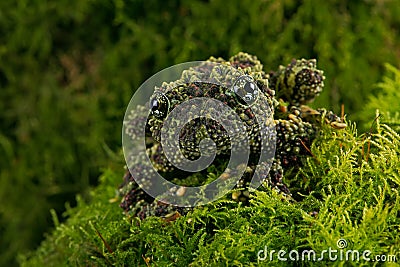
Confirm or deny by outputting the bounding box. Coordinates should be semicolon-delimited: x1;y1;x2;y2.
147;53;276;159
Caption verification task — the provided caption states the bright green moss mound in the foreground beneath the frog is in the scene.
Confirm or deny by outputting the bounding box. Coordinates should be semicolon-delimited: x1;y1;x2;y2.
20;113;400;266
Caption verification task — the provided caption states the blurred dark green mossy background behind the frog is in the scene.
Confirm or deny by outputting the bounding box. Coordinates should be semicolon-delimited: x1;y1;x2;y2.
0;0;400;266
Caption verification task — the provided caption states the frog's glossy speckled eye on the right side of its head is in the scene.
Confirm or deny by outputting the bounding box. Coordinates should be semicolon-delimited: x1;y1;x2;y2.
233;75;258;106
